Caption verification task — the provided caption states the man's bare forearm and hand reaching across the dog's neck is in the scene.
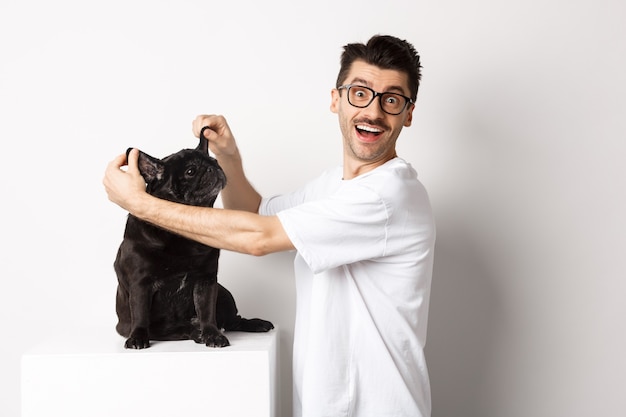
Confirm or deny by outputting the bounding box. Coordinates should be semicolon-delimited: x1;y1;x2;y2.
103;149;294;256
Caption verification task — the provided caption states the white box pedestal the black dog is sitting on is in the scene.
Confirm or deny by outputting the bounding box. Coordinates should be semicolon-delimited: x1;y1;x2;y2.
22;329;278;417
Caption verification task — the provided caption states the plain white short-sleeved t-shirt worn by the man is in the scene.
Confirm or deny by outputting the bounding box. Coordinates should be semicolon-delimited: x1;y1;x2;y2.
259;158;435;417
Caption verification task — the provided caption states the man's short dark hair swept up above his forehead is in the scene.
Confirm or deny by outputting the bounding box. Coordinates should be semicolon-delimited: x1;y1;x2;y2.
337;35;422;100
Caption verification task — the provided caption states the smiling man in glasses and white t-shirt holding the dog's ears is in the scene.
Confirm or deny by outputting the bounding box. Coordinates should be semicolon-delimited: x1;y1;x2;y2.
104;36;435;417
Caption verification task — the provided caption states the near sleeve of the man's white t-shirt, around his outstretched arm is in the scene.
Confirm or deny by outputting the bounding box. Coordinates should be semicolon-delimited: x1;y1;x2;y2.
277;185;389;273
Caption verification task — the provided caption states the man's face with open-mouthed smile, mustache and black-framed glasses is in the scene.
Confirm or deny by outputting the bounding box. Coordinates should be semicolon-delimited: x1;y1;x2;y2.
330;60;414;175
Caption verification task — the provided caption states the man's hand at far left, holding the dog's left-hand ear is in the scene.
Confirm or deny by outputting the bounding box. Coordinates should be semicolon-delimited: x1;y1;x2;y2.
102;149;148;213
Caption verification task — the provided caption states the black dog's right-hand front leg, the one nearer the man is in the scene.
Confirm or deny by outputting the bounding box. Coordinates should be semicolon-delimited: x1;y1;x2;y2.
193;280;230;347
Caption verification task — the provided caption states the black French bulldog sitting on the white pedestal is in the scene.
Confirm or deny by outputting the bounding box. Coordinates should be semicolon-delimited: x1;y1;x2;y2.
114;134;274;349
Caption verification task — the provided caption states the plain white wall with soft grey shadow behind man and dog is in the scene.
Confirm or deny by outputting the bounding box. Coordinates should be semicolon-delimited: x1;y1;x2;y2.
0;0;626;417
